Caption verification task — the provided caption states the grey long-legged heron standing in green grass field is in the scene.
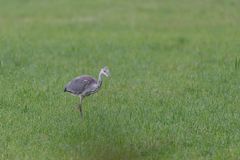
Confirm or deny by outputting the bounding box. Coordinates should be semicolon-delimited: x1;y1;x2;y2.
64;66;110;117
